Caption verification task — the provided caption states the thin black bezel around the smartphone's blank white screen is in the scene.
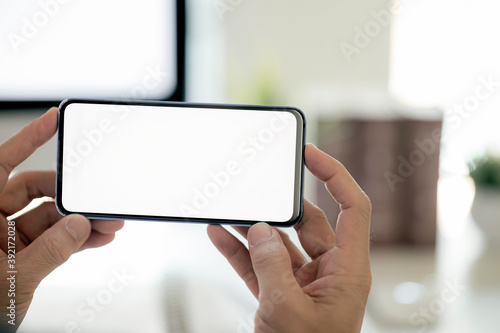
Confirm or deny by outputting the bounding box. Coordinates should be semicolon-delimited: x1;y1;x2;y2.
55;99;306;227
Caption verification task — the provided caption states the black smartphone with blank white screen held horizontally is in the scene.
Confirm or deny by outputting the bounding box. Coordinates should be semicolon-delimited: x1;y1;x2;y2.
56;99;305;226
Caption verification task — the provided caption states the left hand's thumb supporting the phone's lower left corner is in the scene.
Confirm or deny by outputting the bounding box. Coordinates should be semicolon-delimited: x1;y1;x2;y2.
20;215;91;284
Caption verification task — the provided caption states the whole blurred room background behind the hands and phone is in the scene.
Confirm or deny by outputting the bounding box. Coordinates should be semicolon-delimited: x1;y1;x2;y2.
0;0;500;333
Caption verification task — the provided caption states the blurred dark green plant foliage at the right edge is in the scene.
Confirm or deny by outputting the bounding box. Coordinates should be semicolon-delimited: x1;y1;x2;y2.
469;154;500;189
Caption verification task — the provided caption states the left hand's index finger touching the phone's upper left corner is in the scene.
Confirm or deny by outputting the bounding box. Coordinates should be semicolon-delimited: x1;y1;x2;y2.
0;108;57;192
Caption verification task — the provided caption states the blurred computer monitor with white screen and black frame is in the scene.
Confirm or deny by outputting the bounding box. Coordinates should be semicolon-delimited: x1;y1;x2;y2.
0;0;185;109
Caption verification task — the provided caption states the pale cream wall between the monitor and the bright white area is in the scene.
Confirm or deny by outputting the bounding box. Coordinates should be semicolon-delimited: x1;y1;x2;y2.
219;0;391;104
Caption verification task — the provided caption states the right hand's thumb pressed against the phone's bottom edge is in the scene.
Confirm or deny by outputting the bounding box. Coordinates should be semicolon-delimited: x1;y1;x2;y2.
247;223;300;301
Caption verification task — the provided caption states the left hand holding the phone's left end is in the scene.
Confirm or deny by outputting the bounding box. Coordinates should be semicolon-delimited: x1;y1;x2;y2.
0;108;123;332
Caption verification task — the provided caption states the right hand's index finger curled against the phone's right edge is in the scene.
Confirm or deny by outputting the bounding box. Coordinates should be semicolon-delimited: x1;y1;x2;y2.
304;145;371;251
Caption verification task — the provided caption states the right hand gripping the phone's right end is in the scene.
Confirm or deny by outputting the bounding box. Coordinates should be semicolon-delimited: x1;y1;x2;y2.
208;145;371;333
